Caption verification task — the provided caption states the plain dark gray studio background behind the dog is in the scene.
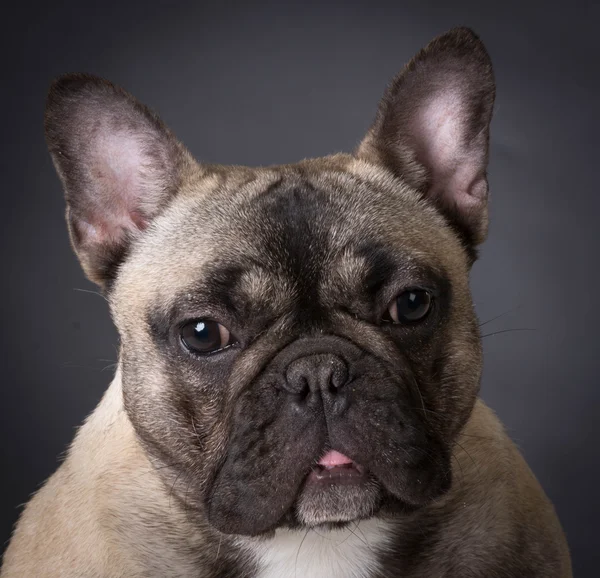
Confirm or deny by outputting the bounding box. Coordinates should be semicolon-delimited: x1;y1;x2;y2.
0;0;600;578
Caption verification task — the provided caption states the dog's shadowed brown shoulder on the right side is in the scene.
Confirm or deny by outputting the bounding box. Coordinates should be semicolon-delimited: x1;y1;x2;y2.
436;399;571;577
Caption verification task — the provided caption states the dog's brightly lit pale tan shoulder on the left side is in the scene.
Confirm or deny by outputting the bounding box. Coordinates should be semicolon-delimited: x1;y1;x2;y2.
0;372;238;578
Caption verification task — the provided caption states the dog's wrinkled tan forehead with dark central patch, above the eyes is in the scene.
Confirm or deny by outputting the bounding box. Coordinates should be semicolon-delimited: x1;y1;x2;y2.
115;164;460;312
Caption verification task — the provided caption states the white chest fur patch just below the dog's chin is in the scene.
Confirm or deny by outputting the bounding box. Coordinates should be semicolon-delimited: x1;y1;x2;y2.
244;519;390;578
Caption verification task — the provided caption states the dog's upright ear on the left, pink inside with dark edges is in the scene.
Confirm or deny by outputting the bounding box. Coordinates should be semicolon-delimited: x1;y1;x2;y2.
45;74;195;288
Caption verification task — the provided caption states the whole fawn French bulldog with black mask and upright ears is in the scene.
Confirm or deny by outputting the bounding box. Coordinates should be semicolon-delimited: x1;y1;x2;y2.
1;28;572;578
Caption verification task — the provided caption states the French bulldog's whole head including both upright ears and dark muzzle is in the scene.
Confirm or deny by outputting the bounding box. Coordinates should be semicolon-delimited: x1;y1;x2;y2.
46;29;494;535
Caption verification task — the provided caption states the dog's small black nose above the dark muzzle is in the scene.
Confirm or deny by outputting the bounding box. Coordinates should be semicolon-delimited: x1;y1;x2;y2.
284;353;348;396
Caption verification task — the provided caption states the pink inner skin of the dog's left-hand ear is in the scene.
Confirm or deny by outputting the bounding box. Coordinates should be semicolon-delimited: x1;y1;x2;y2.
85;130;152;243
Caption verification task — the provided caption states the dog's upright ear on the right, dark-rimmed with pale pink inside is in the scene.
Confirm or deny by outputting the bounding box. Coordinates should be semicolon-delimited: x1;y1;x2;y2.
357;28;495;250
